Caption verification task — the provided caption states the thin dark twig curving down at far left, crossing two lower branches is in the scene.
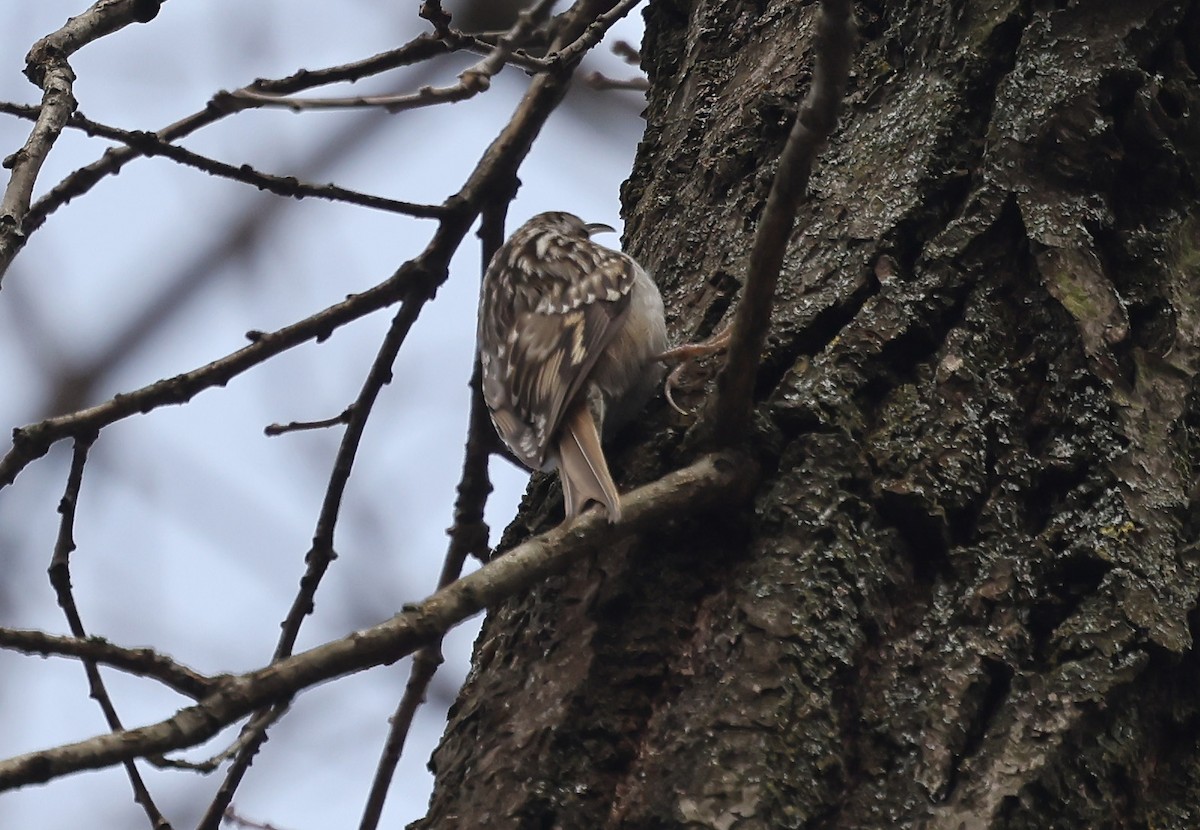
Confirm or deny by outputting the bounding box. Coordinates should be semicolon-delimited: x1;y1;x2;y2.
47;434;170;830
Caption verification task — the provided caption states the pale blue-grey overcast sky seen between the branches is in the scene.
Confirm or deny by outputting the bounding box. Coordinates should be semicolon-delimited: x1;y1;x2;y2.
0;0;642;830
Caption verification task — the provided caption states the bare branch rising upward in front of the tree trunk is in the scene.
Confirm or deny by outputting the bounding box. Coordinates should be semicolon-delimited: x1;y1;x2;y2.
706;0;856;445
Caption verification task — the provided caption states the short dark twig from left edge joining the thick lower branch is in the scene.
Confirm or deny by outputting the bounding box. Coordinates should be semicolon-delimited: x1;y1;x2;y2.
0;628;216;700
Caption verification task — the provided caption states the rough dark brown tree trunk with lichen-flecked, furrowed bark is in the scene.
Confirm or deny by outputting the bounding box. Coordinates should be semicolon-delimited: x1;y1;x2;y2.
415;0;1200;830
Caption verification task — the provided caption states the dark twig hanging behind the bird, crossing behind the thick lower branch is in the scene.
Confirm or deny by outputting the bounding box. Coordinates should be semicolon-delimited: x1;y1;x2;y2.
359;196;511;830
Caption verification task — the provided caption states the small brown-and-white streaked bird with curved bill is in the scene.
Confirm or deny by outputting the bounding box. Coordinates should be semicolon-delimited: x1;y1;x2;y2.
476;211;667;523
